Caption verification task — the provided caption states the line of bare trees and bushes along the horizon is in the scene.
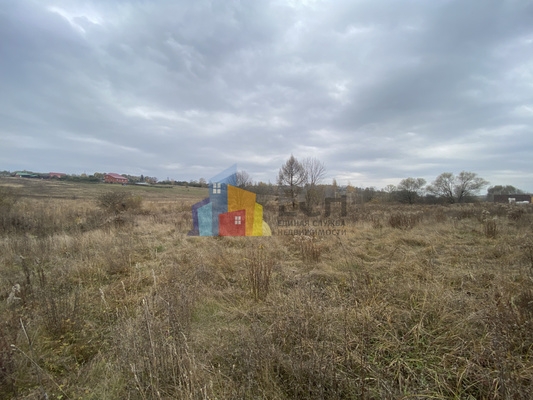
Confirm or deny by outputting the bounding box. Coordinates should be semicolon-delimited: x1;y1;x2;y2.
0;164;524;208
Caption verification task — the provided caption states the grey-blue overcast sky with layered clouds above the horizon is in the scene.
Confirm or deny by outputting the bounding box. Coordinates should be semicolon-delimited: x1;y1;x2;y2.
0;0;533;191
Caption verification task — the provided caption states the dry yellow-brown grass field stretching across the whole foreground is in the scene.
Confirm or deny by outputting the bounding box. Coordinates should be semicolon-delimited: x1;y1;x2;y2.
0;178;533;400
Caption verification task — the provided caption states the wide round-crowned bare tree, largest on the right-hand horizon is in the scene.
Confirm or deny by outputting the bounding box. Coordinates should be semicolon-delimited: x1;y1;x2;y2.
426;171;489;203
